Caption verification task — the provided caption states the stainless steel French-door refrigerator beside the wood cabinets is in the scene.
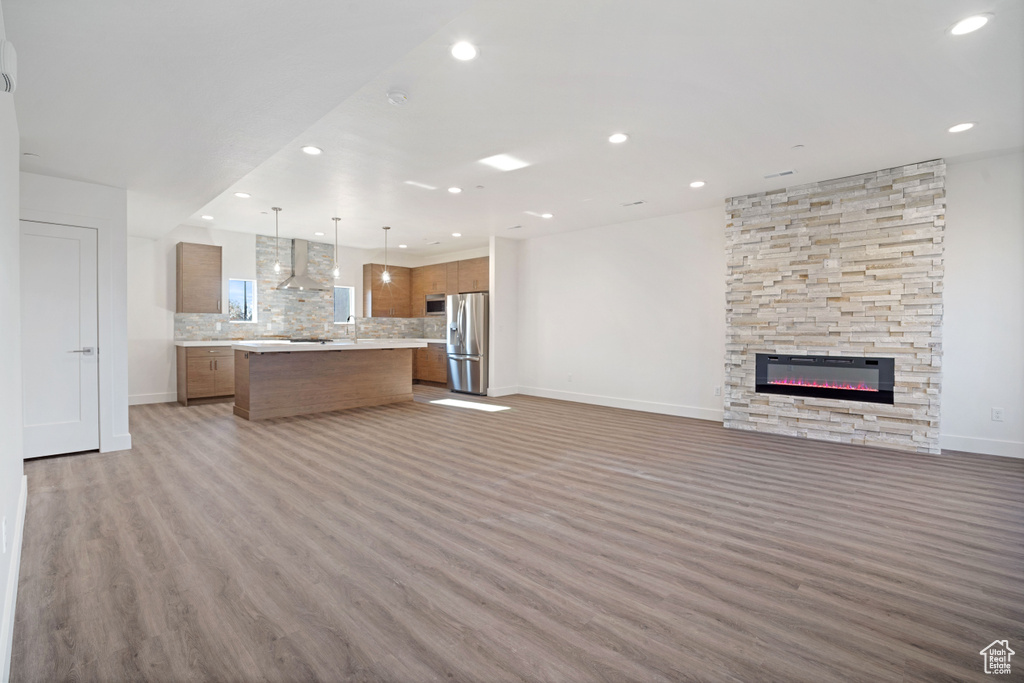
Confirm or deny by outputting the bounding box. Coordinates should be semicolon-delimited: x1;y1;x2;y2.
445;292;487;395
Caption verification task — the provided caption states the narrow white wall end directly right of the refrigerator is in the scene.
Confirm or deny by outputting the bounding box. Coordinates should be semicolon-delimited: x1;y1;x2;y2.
487;237;520;396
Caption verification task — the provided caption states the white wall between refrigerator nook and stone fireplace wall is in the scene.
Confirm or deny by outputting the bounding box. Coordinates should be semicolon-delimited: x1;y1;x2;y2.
518;208;725;420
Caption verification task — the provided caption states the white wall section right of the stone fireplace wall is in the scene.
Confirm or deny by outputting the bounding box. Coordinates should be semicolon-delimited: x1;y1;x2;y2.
940;152;1024;458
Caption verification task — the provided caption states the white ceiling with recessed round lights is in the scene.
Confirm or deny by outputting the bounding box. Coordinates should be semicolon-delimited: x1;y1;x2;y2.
2;0;1024;255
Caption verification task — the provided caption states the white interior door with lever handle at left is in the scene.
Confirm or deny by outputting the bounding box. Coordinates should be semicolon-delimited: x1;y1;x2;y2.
22;220;99;458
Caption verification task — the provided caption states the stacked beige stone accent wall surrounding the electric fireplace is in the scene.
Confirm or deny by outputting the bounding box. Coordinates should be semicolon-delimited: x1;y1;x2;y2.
725;160;945;453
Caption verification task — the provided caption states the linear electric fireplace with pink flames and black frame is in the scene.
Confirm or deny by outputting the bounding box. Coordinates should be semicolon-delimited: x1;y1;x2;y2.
755;353;895;405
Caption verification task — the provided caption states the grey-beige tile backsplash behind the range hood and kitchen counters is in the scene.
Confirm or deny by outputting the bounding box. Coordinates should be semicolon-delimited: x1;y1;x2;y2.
174;236;444;341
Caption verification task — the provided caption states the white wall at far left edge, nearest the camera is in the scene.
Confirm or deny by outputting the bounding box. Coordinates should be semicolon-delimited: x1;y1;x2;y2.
0;18;26;681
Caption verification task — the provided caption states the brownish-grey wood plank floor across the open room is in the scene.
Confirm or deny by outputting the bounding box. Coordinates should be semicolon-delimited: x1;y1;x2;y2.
11;387;1024;682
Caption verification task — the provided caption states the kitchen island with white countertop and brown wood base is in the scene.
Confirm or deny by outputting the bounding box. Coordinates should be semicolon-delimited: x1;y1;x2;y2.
231;339;427;420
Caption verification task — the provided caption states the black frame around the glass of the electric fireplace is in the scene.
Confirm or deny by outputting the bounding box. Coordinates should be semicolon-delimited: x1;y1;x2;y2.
754;353;896;405
